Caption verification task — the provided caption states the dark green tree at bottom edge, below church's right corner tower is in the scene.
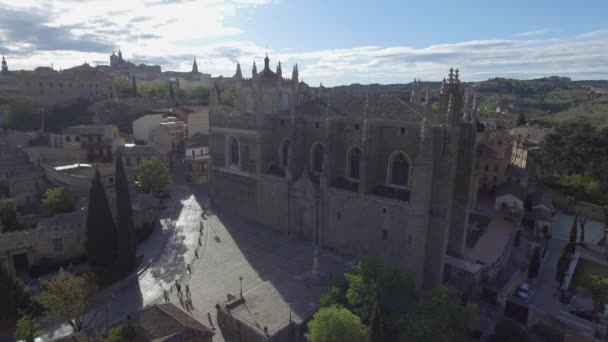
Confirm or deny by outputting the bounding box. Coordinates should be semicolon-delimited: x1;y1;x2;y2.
401;286;476;342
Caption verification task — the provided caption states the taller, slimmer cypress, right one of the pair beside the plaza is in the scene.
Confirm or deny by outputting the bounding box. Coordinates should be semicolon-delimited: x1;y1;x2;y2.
115;155;136;273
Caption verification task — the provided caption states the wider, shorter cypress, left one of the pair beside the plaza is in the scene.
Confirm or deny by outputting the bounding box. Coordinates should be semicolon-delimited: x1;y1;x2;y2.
86;170;116;270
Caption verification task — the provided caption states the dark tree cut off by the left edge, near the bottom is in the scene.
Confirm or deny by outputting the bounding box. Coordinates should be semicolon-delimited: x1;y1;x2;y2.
0;256;31;319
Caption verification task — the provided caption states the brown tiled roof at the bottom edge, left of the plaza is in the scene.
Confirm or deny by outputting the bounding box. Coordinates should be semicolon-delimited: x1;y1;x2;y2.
128;304;215;341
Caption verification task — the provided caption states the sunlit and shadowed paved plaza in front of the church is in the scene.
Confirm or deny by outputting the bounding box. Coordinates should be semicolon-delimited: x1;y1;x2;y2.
44;175;348;341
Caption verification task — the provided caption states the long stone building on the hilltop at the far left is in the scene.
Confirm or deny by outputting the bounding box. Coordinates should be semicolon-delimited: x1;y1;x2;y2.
0;57;114;106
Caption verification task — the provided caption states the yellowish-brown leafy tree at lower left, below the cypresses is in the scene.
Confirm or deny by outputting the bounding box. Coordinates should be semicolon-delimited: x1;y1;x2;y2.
34;275;97;332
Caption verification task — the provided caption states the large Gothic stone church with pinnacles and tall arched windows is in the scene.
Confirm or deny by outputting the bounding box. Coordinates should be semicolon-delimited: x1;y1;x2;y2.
209;57;476;287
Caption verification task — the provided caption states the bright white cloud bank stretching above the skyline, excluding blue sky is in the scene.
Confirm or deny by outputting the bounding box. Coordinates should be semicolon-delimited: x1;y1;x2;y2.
0;0;608;85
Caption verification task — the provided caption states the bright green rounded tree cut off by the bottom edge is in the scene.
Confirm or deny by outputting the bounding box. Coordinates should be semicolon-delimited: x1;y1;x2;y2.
306;306;367;342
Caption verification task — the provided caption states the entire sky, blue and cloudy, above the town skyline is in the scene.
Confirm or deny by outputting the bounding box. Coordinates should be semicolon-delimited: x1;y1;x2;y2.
0;0;608;86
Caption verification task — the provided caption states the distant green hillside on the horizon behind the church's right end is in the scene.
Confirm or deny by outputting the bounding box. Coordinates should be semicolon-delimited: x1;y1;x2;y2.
332;76;608;127
